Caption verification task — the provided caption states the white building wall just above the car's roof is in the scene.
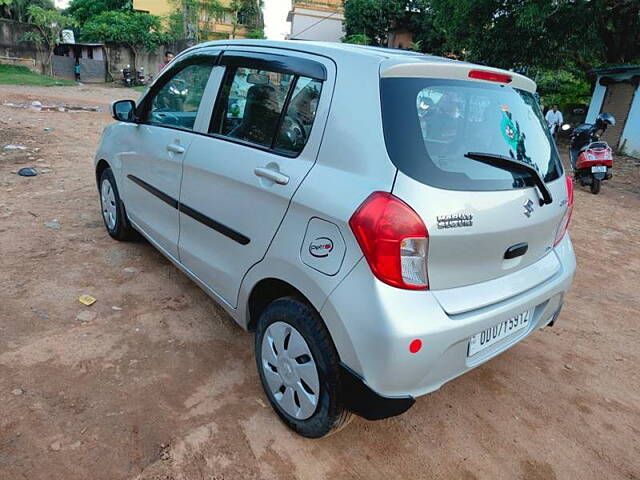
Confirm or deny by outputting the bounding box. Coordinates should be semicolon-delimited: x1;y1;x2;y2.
289;5;344;42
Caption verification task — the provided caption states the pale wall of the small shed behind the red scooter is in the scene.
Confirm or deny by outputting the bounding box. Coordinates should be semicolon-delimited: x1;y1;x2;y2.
586;69;640;158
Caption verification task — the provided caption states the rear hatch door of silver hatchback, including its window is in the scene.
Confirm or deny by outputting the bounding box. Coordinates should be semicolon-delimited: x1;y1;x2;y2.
381;64;567;295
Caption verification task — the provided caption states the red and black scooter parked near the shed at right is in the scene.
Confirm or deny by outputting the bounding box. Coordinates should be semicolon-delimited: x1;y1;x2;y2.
562;112;616;195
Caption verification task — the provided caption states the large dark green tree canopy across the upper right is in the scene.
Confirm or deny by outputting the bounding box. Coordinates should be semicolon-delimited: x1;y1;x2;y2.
344;0;640;70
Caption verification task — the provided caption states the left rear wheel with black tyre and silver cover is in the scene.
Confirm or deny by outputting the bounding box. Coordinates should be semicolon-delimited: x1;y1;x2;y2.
255;297;352;438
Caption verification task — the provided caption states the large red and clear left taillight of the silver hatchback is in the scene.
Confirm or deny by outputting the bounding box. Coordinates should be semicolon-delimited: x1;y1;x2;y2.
349;192;429;290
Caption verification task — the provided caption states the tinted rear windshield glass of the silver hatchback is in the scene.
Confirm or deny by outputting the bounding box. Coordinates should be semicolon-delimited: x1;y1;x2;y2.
381;78;562;191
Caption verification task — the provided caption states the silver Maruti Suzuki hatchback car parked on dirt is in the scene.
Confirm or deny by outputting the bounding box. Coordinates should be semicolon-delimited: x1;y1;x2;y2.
95;40;576;437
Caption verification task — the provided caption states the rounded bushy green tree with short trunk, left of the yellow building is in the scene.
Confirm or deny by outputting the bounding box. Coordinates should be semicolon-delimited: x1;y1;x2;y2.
81;10;167;69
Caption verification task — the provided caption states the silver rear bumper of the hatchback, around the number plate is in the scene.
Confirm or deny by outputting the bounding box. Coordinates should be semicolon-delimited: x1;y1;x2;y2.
321;235;576;412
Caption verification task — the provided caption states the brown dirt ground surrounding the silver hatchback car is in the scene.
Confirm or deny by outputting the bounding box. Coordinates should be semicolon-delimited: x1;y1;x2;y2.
0;86;640;480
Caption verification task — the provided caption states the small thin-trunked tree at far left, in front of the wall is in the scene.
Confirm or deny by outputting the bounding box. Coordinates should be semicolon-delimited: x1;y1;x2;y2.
21;5;73;75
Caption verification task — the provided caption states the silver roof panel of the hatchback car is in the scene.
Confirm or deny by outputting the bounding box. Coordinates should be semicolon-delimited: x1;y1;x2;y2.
193;39;536;92
